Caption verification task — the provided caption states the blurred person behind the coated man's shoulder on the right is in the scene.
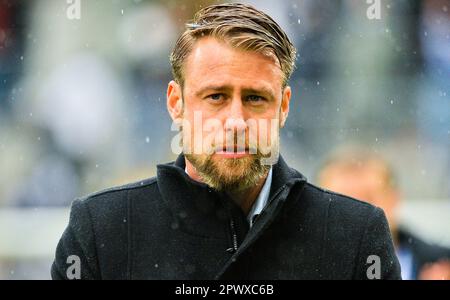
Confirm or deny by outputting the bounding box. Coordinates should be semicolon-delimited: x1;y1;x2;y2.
318;147;450;280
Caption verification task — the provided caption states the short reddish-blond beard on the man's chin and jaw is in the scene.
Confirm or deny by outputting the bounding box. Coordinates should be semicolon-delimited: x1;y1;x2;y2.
185;152;271;193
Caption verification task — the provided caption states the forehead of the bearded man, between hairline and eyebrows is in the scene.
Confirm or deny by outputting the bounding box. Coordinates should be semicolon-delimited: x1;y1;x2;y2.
184;37;283;89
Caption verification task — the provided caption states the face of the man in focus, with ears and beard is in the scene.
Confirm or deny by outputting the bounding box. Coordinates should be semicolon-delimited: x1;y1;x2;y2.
168;37;291;190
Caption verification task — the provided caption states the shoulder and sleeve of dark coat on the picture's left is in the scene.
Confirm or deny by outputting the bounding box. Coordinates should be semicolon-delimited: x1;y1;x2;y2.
52;178;160;279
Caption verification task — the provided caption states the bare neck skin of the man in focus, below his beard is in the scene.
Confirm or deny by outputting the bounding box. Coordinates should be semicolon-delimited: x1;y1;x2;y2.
185;158;268;215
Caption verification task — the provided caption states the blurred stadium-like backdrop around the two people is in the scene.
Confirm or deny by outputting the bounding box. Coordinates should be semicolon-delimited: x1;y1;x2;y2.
0;0;450;279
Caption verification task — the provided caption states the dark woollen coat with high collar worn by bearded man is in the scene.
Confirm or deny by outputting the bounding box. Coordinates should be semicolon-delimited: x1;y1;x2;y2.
51;155;400;279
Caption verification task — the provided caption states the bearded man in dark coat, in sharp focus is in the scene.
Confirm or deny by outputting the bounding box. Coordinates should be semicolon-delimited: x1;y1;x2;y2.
52;4;400;279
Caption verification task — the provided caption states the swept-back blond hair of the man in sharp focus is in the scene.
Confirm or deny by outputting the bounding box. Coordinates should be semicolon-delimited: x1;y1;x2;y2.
170;3;296;87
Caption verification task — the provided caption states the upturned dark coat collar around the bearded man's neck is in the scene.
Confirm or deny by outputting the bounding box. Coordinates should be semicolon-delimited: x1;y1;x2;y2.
157;154;306;238
